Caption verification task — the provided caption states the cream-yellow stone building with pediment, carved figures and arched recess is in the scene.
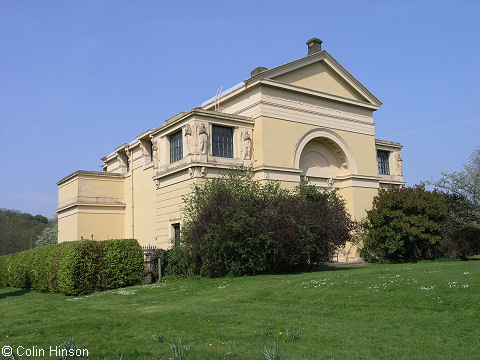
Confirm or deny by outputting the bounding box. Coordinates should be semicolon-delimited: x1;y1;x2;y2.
57;38;404;261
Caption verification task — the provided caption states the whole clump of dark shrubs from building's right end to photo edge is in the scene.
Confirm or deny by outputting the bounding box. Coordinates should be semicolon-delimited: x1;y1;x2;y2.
360;186;480;262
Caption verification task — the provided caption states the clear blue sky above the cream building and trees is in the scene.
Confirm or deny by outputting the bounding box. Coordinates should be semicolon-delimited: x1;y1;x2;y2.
0;0;480;217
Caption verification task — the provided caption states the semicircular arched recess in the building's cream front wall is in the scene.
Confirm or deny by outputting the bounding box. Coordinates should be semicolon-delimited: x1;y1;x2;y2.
293;128;357;178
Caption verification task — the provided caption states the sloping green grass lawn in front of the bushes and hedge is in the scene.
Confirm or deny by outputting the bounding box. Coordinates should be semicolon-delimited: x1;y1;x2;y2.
0;260;480;360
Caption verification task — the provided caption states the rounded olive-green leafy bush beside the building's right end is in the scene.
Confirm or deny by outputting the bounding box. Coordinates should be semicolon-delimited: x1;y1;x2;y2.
360;186;448;262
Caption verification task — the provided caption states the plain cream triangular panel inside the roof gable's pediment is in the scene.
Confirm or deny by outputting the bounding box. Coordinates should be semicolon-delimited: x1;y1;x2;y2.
272;61;368;102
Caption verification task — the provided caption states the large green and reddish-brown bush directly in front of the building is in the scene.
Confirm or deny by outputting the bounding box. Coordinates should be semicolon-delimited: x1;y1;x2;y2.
168;170;355;277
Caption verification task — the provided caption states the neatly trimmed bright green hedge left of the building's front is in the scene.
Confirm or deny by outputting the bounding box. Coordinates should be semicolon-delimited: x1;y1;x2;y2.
0;239;144;295
